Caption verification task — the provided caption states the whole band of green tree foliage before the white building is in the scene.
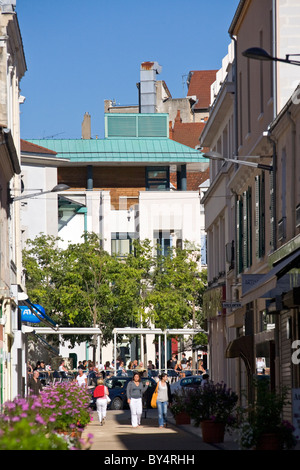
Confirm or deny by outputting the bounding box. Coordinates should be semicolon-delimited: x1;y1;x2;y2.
23;233;206;344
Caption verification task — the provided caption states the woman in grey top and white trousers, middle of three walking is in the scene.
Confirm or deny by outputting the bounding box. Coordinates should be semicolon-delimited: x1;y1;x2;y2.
126;372;150;428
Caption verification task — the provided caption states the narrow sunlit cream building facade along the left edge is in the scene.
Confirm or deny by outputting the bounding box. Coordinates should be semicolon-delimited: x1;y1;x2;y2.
0;1;26;406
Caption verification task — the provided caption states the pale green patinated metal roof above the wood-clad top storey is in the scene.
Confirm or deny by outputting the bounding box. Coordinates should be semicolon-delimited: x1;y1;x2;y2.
28;138;209;164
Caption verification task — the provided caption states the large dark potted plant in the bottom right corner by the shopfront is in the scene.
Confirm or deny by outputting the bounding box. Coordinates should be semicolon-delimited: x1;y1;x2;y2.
240;377;297;450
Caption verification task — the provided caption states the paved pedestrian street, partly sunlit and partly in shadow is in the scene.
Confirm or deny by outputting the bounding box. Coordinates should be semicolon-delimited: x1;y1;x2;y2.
83;409;238;451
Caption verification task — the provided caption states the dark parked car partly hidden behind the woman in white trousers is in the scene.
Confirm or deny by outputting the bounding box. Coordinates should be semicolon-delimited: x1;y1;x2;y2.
90;375;156;410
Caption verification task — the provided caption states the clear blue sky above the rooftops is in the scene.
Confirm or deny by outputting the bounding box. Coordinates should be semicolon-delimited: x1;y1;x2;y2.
16;0;239;139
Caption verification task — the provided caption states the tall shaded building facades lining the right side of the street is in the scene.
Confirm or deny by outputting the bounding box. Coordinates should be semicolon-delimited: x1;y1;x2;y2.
201;0;300;419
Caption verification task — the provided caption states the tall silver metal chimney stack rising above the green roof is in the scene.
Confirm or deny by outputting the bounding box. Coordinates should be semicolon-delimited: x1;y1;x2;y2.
140;62;162;113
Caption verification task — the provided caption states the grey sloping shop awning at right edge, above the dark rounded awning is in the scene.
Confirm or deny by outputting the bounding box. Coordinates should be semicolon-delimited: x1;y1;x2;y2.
241;250;300;305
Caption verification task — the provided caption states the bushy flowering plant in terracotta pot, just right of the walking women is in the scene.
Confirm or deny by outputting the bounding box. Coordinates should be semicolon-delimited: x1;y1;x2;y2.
188;382;238;443
